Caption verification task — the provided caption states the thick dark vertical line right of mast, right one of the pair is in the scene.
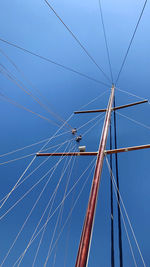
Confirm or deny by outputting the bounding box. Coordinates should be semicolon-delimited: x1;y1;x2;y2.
114;96;123;267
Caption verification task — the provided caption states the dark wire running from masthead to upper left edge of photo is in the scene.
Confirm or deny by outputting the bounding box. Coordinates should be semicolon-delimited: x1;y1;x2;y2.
0;38;109;87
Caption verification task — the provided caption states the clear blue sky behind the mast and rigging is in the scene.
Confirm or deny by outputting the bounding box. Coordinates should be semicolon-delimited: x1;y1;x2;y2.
0;0;150;267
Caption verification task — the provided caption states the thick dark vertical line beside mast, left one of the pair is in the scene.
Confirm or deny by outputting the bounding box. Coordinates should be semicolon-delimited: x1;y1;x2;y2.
110;118;115;267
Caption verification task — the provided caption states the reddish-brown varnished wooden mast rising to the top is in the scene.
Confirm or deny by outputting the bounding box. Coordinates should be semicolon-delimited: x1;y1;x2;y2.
75;85;115;267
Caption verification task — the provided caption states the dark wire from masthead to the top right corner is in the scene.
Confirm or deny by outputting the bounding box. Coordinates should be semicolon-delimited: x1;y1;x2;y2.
115;0;148;84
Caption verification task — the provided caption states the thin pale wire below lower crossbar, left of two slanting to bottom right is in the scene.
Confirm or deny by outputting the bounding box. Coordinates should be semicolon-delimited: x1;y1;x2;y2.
106;157;137;267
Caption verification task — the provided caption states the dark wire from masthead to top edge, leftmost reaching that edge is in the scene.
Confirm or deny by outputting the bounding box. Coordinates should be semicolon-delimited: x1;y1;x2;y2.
43;0;110;81
